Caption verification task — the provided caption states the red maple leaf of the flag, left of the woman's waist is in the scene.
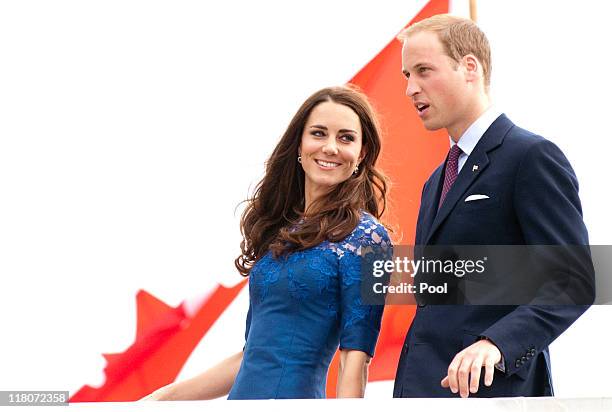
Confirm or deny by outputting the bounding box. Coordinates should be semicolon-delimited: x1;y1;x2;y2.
70;280;246;402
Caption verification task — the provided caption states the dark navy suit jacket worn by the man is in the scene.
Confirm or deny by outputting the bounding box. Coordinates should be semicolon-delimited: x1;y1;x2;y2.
393;114;594;397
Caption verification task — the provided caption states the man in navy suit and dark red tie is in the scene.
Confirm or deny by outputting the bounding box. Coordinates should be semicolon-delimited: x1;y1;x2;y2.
393;15;593;397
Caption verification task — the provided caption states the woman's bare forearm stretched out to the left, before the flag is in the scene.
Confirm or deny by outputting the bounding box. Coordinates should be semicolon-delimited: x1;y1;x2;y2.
151;352;242;401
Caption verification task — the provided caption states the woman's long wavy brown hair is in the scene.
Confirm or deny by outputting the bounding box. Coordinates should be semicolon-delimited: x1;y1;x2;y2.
234;86;388;276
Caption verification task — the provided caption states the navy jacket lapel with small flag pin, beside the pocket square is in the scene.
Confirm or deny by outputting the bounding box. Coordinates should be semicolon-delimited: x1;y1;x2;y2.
424;114;513;244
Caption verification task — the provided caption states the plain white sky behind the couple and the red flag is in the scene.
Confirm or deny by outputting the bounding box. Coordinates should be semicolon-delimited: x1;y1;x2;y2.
0;0;612;397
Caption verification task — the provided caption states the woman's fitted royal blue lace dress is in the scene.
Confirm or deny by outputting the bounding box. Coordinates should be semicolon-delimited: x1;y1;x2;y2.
228;212;392;399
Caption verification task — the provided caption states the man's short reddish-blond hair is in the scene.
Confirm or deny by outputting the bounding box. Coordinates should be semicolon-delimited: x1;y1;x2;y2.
397;14;491;88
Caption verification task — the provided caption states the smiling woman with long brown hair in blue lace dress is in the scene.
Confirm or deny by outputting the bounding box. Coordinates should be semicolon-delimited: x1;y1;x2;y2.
144;87;391;400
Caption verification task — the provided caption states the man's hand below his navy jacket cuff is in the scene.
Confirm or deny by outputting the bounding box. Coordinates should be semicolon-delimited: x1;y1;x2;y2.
441;339;501;398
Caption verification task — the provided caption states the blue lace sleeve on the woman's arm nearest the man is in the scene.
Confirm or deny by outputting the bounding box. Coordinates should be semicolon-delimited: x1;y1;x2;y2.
339;220;392;356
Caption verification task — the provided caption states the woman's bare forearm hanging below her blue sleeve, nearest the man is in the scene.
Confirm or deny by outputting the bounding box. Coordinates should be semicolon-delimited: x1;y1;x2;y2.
336;350;370;398
